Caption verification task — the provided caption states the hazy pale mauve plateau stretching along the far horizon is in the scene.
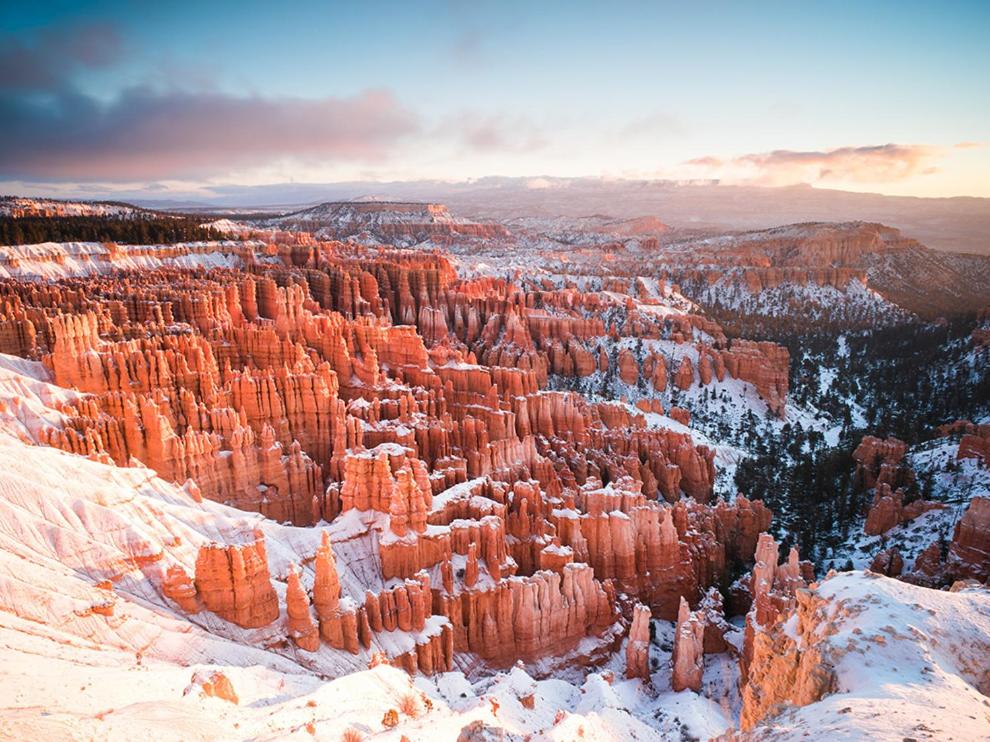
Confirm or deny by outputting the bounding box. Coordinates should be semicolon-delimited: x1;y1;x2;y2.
114;177;990;255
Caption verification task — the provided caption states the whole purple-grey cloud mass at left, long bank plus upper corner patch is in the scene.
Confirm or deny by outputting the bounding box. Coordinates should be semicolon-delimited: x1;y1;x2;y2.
0;23;419;182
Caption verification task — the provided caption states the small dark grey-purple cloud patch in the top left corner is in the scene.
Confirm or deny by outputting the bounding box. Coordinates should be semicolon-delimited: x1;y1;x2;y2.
0;23;123;92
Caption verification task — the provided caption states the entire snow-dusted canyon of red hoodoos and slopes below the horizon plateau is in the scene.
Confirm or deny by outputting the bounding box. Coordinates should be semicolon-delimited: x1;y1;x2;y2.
0;200;990;740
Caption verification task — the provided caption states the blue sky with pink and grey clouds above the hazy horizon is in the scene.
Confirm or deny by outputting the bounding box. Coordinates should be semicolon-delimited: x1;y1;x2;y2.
0;0;990;198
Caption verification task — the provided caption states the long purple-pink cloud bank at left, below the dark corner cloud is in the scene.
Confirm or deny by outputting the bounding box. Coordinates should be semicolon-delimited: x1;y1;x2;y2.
0;87;419;180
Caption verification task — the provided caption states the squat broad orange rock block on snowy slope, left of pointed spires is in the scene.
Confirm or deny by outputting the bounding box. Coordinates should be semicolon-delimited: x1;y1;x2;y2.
196;534;279;629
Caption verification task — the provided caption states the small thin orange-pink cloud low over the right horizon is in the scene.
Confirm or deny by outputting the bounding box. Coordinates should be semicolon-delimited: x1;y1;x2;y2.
684;144;945;185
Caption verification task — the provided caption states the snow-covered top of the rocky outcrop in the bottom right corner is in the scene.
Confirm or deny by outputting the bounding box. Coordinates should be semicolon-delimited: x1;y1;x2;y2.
749;572;990;742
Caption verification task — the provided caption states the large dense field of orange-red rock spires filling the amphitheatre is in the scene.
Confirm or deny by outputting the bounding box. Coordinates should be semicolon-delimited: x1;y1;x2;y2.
0;238;808;673
